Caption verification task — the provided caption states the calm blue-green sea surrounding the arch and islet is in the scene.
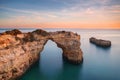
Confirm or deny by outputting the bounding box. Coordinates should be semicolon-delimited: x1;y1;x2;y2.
0;28;120;80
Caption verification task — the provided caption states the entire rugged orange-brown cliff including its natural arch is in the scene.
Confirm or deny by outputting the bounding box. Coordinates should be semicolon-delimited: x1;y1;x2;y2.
0;29;83;80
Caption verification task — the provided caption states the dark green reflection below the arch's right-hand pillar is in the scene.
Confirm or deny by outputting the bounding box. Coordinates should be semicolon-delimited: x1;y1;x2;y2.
56;61;82;80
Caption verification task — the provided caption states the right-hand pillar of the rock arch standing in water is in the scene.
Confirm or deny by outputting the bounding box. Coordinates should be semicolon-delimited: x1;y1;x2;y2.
50;31;83;64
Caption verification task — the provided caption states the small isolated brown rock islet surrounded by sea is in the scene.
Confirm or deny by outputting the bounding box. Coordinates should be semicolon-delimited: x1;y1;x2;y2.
89;37;111;47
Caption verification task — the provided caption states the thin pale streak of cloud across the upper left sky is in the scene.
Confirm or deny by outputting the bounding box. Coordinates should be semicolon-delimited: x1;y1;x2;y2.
0;6;58;20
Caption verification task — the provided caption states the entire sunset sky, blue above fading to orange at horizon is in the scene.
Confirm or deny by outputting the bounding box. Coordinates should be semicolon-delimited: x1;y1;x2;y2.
0;0;120;29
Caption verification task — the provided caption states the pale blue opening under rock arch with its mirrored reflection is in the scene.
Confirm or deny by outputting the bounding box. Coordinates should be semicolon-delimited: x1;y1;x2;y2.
39;40;63;76
